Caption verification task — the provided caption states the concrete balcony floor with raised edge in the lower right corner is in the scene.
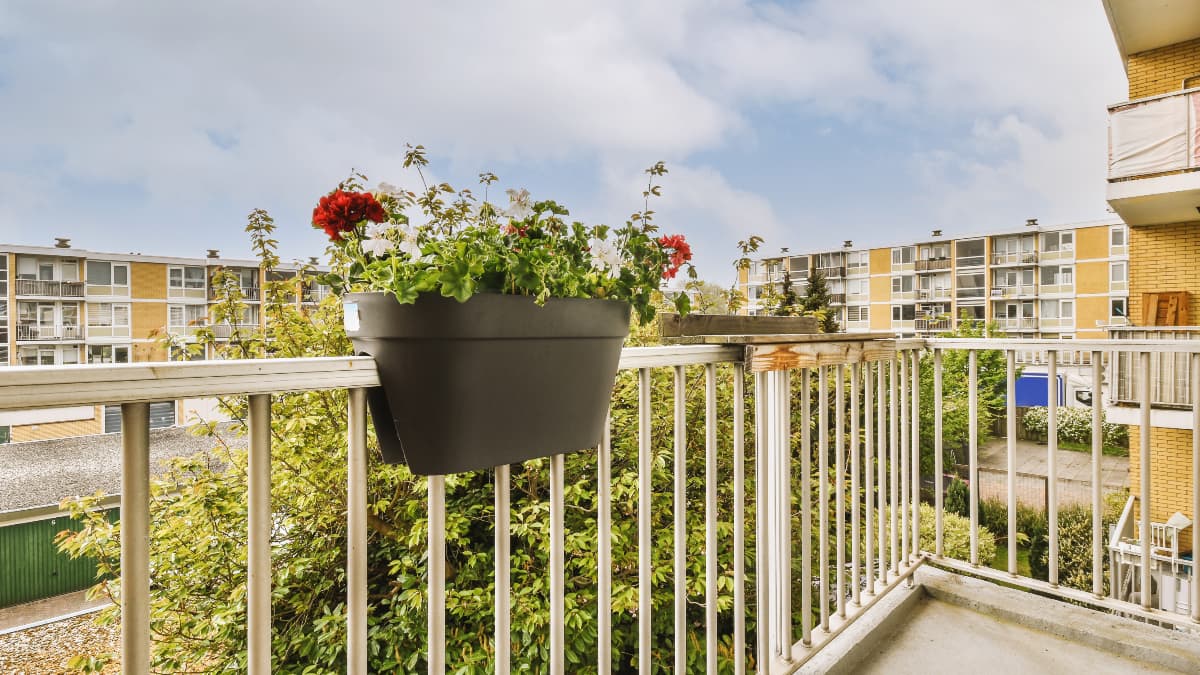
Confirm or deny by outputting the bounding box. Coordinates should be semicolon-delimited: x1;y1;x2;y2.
799;566;1200;675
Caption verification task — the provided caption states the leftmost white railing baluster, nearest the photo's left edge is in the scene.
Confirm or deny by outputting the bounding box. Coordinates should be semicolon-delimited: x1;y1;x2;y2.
121;404;150;673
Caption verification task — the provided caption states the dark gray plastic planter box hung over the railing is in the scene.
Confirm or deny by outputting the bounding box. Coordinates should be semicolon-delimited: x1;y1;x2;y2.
343;293;630;476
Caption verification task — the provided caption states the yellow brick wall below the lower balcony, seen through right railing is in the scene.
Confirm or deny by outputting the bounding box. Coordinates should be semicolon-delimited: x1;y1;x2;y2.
1129;424;1195;550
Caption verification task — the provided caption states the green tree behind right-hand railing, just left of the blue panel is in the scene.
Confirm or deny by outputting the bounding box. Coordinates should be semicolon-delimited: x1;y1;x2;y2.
920;319;1020;473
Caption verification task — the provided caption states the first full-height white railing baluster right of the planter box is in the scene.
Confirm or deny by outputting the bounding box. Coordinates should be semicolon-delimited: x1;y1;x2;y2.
637;368;654;673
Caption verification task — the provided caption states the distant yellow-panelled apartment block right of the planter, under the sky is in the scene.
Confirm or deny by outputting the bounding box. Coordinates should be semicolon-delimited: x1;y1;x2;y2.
740;219;1129;339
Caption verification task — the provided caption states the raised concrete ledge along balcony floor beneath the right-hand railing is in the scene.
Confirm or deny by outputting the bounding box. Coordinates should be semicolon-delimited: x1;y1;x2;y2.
916;566;1200;673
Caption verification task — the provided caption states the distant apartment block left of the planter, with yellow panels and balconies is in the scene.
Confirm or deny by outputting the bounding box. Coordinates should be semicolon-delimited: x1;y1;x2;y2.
0;239;329;442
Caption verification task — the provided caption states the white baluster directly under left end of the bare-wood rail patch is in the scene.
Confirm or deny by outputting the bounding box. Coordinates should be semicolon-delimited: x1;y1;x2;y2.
754;372;773;671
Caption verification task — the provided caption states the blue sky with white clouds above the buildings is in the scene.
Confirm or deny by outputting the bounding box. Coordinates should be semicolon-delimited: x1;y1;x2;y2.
0;0;1128;285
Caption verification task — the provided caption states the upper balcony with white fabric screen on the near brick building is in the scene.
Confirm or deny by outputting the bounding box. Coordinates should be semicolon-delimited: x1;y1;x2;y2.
1108;84;1200;226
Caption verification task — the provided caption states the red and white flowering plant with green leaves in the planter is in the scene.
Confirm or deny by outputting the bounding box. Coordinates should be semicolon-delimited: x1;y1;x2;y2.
312;145;696;323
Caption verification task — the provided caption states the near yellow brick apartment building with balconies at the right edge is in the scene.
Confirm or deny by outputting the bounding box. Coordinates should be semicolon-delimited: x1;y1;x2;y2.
1097;0;1200;542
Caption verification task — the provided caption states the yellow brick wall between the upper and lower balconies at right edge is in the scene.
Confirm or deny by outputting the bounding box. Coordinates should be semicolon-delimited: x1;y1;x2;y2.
1129;222;1200;324
